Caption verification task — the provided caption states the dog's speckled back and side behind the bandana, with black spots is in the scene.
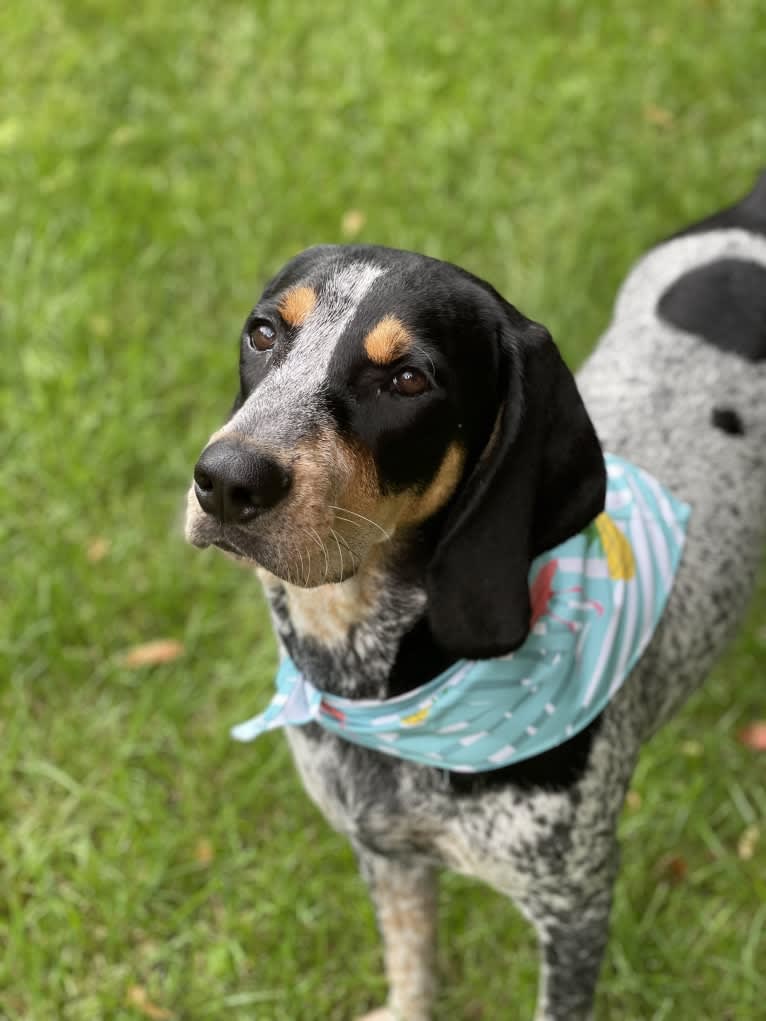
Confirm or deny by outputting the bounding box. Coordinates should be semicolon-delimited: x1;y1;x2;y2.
578;174;766;730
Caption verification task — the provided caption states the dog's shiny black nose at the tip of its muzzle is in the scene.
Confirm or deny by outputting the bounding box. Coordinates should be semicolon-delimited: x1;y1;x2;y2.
194;440;292;525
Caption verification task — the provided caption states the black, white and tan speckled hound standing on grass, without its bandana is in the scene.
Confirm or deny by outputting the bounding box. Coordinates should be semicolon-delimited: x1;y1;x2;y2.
186;174;766;1021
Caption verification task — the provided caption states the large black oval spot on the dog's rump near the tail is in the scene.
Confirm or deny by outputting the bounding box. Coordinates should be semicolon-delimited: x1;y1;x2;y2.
658;258;766;361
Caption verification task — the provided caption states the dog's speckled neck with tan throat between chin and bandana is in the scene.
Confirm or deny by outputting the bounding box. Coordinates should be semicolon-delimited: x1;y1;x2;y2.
259;543;451;698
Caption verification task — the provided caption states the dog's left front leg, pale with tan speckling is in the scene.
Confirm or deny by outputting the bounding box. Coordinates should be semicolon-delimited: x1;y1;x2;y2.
356;848;437;1021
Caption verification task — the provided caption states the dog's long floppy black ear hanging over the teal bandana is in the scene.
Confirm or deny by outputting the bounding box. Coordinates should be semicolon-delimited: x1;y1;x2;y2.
427;299;607;659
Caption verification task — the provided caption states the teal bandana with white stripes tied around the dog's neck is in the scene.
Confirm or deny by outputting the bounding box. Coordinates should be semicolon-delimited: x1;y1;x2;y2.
232;454;689;773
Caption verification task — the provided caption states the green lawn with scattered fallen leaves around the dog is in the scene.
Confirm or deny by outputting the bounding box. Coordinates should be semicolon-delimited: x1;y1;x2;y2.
0;0;766;1021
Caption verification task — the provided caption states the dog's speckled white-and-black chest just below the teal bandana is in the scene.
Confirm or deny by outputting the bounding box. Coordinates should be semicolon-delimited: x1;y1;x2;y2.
287;728;575;895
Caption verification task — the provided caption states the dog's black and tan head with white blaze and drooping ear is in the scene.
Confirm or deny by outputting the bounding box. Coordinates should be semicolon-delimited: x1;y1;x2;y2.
187;246;606;657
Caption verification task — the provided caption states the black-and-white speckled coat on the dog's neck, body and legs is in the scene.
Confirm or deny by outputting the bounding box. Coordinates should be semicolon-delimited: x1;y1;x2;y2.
184;178;766;1021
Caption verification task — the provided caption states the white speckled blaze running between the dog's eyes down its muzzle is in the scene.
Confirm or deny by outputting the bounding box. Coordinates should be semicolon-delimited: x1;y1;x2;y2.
227;262;386;432
